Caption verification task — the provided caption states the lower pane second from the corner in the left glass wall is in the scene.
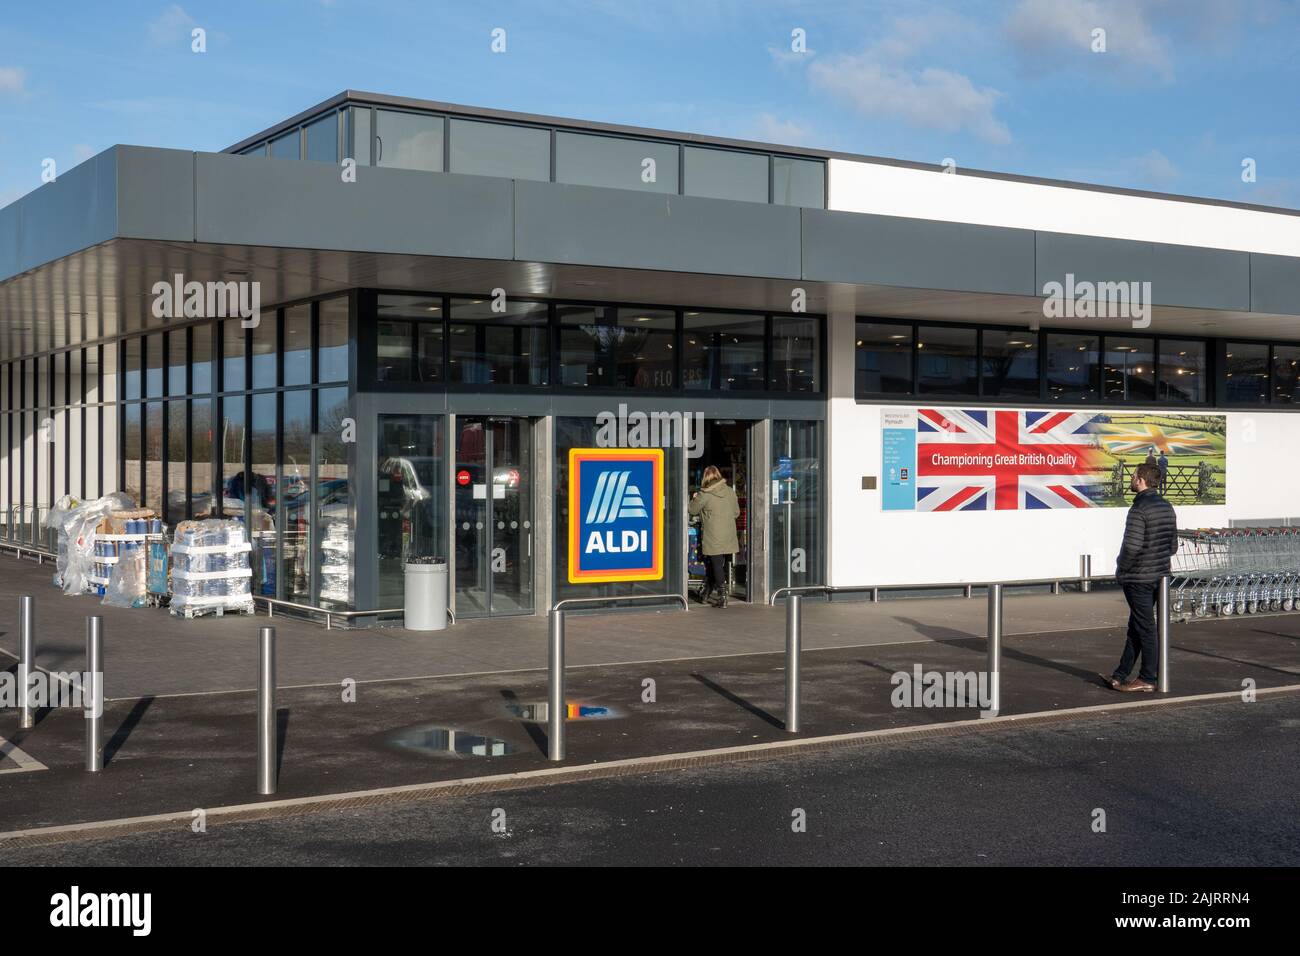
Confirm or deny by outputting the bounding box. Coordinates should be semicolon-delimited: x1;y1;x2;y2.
276;389;312;606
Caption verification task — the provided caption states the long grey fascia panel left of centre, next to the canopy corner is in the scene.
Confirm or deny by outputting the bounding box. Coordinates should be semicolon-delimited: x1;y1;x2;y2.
195;153;512;259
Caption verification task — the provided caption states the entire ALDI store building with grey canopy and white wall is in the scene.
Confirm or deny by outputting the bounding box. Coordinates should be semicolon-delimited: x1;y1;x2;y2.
0;92;1300;623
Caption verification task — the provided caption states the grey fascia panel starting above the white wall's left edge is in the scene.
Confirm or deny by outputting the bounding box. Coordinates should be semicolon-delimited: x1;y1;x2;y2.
803;209;1035;295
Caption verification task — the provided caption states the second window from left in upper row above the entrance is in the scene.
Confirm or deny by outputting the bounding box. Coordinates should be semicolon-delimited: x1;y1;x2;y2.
447;299;551;385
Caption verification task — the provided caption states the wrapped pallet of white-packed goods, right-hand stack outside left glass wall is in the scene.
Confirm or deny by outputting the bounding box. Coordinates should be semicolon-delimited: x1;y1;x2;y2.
170;519;254;618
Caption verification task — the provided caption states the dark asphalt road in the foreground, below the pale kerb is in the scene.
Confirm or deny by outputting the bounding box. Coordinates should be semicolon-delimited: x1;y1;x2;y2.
0;695;1300;866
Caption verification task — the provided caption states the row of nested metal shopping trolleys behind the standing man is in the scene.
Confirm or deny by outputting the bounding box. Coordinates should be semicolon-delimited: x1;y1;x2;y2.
1169;527;1300;618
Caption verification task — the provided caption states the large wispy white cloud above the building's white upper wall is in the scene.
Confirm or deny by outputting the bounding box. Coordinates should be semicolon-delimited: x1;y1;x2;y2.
809;17;1011;143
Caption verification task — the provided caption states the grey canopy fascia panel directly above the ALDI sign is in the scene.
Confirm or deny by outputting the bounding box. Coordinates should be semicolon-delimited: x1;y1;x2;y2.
515;182;800;280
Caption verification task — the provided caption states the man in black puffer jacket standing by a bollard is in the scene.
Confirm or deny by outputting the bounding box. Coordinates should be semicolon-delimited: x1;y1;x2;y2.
1108;464;1178;693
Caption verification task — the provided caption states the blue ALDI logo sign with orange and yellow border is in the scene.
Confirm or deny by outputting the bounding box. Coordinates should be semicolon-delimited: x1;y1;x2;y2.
568;449;663;584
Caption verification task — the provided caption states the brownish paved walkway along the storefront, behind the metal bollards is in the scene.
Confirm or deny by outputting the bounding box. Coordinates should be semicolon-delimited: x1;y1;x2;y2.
0;548;1127;698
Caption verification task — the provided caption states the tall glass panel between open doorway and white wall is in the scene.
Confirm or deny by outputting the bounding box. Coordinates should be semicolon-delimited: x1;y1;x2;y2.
768;421;826;591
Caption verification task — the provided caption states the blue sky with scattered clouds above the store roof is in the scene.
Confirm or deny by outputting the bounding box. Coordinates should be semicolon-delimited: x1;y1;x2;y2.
0;0;1300;208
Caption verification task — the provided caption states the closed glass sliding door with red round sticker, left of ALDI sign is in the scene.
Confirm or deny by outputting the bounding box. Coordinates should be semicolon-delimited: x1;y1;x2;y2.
452;415;533;618
